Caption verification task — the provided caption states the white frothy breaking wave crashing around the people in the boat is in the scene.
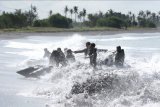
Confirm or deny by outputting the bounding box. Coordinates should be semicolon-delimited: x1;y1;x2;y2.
15;34;160;107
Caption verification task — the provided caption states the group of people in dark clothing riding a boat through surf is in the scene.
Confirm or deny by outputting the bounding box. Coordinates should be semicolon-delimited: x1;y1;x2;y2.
43;42;125;68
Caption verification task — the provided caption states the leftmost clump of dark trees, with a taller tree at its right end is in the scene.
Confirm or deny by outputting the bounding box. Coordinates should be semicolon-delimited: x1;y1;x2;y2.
0;5;38;28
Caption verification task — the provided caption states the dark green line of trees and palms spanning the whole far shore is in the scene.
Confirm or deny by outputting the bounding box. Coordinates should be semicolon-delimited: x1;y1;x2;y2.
0;5;160;29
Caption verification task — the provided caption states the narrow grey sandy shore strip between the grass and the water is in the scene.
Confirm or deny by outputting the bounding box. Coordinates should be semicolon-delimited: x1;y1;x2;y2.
0;28;160;40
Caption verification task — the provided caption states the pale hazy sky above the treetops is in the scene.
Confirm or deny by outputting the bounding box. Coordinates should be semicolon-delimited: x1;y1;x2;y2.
0;0;160;19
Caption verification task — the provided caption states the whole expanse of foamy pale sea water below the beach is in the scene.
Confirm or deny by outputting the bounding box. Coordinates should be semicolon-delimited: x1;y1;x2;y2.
0;33;160;107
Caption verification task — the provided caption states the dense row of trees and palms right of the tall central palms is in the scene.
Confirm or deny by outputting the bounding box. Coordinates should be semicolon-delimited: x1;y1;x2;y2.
86;9;160;28
